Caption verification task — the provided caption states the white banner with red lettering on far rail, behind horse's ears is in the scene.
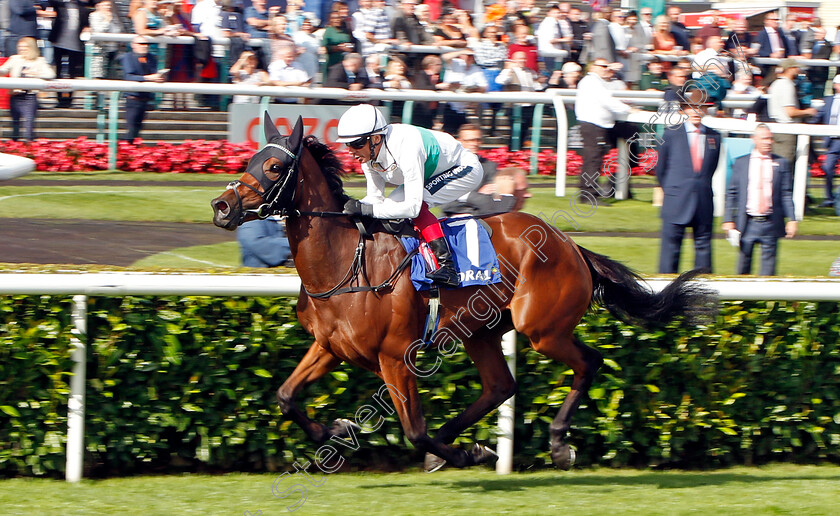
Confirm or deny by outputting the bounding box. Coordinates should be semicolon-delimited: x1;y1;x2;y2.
228;104;391;149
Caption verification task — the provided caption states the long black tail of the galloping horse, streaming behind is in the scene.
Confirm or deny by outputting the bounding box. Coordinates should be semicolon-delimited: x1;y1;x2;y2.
579;247;717;326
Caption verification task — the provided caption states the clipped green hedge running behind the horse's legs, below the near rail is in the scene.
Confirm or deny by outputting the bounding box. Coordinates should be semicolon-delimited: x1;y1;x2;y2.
0;296;840;476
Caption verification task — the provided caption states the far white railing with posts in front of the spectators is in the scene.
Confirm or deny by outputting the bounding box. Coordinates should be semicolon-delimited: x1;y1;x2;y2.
0;78;840;219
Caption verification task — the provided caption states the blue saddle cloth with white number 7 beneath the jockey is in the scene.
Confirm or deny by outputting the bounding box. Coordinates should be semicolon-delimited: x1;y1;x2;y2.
400;217;502;290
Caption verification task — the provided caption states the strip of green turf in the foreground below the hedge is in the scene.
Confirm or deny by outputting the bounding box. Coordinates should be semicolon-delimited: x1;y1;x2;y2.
0;465;840;516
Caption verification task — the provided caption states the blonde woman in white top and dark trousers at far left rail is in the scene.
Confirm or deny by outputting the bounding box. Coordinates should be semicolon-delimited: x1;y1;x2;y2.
0;36;55;141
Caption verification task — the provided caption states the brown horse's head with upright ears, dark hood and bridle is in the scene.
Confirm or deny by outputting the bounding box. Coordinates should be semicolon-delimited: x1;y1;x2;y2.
210;113;303;230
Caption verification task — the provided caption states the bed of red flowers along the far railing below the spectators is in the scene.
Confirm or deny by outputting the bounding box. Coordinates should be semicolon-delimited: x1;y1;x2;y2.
0;136;840;177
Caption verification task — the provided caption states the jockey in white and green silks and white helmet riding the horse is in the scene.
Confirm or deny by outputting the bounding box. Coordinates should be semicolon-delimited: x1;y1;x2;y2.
337;104;484;287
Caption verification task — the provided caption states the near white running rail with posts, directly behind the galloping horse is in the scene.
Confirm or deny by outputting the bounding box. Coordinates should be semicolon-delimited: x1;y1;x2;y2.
0;272;840;482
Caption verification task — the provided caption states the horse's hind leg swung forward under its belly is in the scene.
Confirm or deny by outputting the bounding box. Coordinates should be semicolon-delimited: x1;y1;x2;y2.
435;331;516;444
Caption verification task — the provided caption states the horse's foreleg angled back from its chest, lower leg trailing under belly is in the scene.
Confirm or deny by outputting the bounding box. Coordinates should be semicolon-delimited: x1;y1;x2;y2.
380;357;476;468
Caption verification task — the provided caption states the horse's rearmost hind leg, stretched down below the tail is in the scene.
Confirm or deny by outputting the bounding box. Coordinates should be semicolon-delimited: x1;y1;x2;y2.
531;335;604;469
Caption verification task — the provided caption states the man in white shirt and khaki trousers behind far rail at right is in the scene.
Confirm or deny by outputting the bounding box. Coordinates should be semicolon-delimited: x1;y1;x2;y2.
767;58;817;163
